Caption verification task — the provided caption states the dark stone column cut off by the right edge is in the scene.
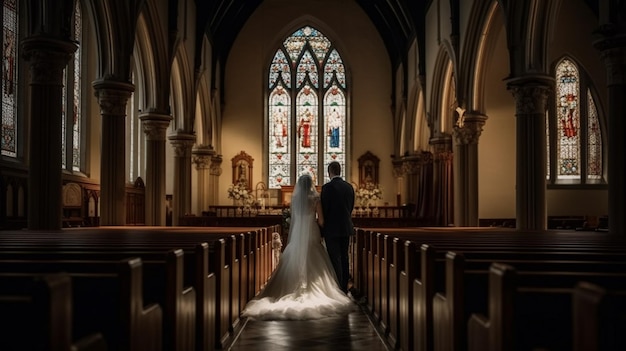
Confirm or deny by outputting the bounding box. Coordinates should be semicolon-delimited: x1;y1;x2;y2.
594;6;626;236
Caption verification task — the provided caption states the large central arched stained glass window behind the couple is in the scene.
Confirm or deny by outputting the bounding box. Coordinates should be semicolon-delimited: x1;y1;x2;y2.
268;26;348;189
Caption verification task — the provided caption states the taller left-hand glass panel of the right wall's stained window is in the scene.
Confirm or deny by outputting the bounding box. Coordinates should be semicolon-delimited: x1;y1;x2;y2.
556;59;580;179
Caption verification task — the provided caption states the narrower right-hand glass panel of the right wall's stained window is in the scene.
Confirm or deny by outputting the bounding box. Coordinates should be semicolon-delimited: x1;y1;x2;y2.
587;89;602;180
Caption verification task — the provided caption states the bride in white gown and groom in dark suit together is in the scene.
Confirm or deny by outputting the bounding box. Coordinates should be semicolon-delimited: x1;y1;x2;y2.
242;162;355;320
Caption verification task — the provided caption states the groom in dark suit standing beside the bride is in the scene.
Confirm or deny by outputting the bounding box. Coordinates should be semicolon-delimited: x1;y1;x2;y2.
320;161;354;293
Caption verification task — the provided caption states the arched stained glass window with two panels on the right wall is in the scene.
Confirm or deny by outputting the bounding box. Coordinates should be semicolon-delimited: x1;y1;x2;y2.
546;58;603;184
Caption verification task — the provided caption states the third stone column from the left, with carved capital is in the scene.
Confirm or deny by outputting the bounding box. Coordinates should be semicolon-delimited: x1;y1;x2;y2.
139;112;172;226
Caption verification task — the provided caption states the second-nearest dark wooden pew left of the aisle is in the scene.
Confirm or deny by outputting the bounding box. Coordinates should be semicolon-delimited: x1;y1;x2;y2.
0;258;163;350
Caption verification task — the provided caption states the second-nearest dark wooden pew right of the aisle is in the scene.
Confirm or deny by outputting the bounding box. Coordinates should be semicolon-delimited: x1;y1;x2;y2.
468;263;626;351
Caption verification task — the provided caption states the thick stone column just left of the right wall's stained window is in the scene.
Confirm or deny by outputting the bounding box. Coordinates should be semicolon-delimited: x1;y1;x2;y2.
507;76;553;230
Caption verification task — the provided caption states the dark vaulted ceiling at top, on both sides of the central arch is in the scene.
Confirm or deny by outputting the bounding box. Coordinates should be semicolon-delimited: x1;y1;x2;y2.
196;0;430;72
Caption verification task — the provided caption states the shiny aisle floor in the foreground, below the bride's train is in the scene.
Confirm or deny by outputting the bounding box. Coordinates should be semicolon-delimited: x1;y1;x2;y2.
229;308;391;351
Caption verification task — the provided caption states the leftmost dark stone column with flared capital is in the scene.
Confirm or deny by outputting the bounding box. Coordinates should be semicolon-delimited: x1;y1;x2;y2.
22;35;77;230
